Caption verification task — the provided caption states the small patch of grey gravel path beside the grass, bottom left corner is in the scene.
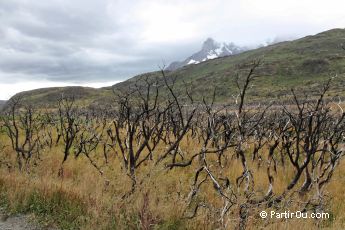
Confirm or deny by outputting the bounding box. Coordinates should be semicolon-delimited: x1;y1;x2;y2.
0;209;40;230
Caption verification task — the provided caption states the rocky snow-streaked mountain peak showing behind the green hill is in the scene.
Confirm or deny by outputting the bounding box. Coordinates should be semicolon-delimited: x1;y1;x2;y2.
166;38;248;70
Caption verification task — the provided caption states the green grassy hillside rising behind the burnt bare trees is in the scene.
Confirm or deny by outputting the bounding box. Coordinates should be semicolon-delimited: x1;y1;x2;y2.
6;29;345;105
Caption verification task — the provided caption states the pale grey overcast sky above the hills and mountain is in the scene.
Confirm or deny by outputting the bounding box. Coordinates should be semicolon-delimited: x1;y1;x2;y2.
0;0;345;99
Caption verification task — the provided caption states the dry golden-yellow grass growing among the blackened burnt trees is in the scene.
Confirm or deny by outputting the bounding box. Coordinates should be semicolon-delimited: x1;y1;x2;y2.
0;132;345;229
